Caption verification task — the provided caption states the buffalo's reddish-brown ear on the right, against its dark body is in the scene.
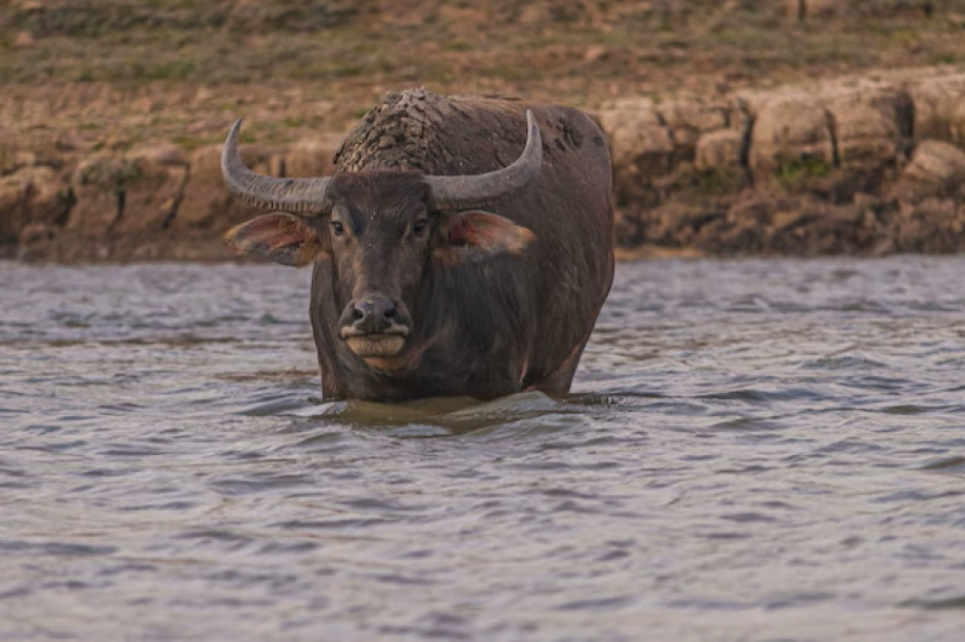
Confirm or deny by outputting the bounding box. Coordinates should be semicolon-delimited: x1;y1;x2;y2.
434;210;536;263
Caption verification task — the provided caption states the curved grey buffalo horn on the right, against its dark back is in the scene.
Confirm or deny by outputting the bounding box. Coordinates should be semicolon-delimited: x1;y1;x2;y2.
425;109;543;209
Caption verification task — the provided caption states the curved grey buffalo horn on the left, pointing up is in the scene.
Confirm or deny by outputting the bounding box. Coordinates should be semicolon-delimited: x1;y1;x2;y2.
221;118;329;212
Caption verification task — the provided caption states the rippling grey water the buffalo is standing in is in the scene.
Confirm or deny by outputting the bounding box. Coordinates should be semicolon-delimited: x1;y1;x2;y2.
0;257;965;642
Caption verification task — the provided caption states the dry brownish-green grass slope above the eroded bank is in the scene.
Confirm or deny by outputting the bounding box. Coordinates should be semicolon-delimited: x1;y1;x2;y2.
0;0;965;152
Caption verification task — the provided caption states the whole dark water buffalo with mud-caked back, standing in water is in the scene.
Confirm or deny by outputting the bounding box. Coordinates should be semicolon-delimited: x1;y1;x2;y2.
222;89;613;400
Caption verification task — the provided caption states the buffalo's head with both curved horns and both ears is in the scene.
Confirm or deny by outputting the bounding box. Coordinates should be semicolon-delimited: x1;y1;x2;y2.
221;111;542;368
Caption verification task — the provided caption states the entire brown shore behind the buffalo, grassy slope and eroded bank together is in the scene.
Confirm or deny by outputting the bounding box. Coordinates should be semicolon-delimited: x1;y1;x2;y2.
0;0;965;261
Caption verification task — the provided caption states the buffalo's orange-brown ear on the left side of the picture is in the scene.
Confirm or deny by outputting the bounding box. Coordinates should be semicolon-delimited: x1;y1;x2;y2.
224;212;328;267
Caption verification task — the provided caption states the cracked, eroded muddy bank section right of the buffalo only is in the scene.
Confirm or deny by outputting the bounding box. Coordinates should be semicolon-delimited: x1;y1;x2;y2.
600;74;965;255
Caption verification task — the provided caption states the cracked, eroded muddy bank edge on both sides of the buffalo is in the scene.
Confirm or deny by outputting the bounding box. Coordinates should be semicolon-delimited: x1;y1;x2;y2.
0;71;965;261
